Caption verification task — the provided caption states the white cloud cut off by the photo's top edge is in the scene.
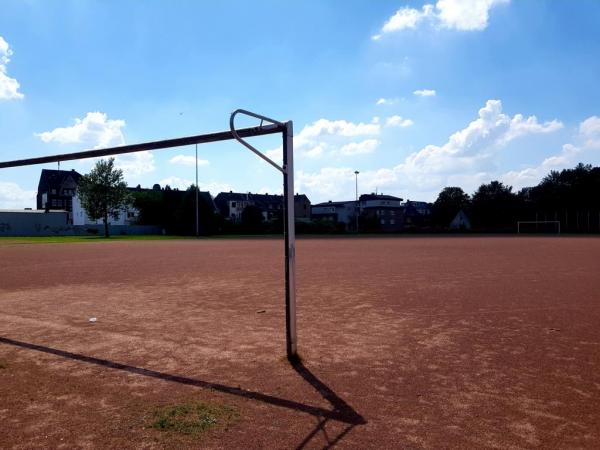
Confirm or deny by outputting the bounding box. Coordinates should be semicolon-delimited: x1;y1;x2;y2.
371;0;510;41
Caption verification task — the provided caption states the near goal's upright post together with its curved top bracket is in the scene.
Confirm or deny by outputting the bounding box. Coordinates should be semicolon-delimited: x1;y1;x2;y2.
229;109;298;360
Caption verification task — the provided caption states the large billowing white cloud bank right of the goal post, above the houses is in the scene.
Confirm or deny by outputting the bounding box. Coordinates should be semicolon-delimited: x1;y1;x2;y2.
297;100;564;201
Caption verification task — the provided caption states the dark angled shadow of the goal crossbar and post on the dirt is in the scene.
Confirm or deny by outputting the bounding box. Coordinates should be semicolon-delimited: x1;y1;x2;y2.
0;337;367;425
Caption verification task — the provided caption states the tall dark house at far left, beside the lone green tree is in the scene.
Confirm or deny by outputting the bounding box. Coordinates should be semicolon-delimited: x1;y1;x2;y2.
36;169;81;214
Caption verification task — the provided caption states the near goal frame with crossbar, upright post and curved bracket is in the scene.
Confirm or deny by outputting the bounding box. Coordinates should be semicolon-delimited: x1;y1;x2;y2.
0;109;297;359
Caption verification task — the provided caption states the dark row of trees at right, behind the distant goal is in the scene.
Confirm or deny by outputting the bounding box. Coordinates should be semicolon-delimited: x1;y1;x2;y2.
432;164;600;232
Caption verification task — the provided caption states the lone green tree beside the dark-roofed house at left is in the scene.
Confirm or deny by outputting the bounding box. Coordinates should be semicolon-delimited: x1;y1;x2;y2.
77;158;130;237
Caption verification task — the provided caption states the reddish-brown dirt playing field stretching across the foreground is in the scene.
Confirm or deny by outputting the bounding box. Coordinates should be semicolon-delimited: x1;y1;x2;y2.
0;237;600;449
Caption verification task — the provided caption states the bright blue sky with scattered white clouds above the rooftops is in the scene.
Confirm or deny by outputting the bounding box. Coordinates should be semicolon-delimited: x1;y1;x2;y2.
0;0;600;208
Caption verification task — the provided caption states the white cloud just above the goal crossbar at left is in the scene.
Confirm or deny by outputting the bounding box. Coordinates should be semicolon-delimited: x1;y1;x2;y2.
36;112;125;149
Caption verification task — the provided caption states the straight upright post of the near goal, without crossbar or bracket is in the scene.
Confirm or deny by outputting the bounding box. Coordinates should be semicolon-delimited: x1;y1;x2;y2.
283;121;298;359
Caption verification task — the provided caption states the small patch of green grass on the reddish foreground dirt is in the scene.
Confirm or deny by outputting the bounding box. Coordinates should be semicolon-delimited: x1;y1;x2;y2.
149;402;239;436
